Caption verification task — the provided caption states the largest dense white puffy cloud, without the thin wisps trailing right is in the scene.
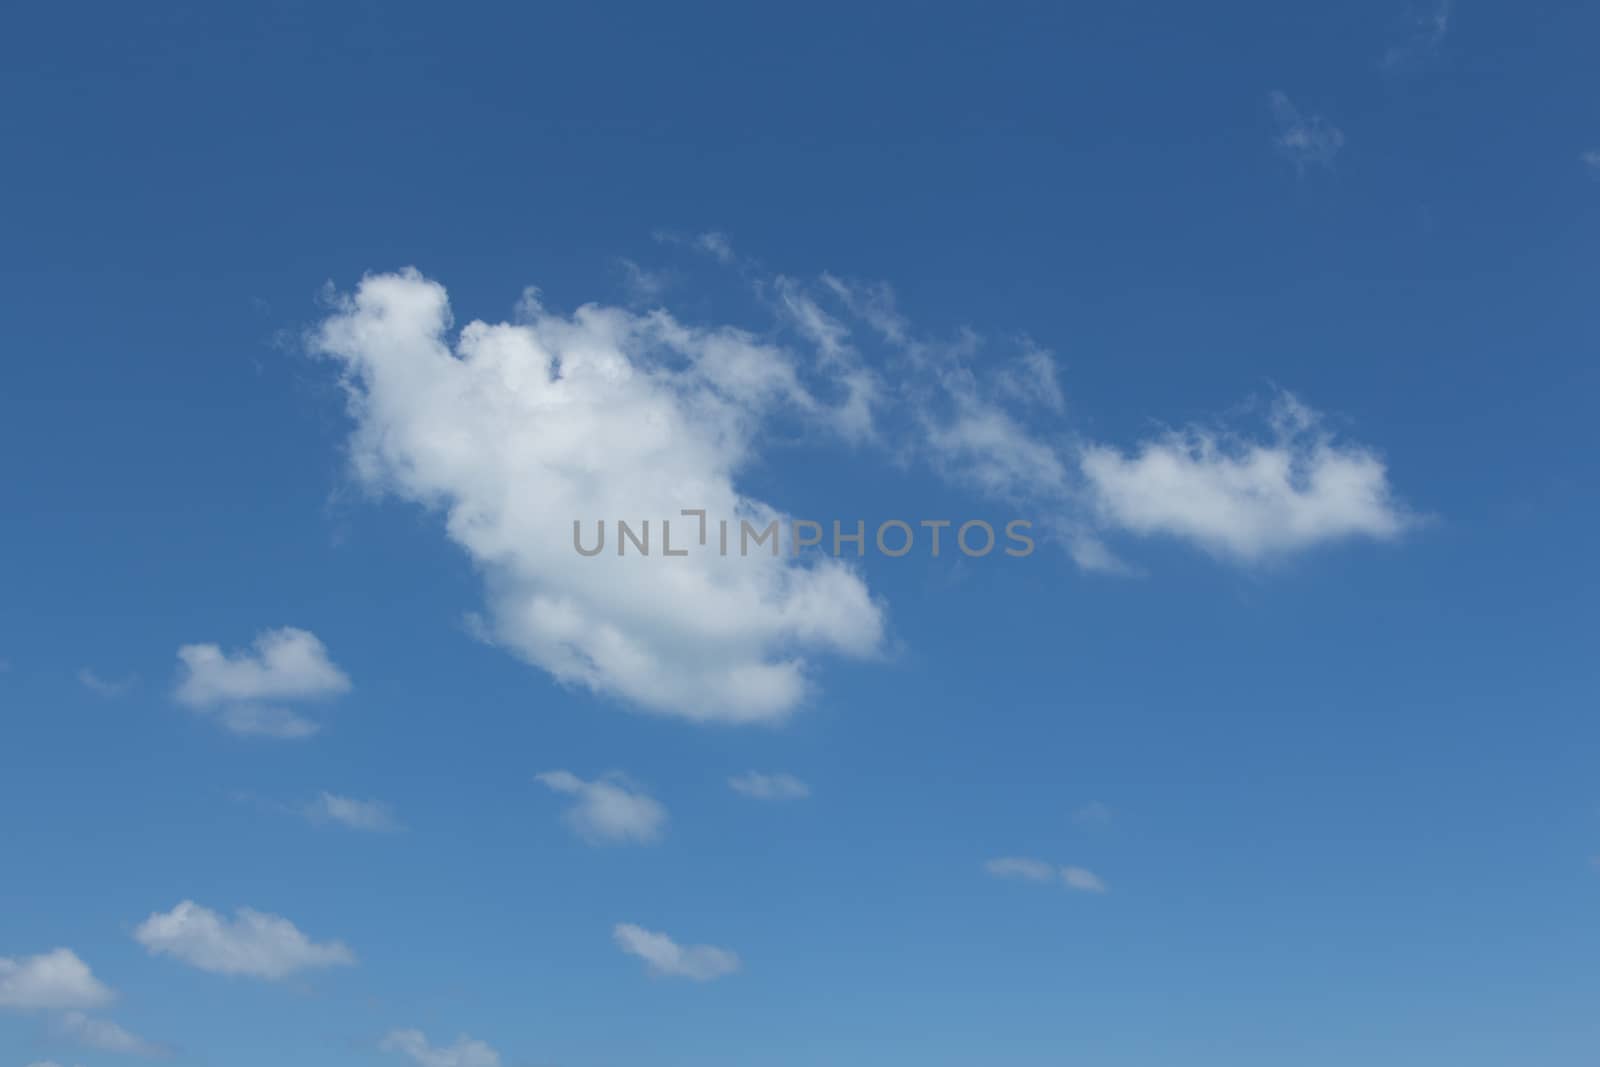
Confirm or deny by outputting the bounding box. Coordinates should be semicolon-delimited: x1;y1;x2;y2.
314;270;883;721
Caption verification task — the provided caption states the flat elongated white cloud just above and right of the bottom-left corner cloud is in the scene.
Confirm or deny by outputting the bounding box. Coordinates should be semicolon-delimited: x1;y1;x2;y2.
133;901;355;979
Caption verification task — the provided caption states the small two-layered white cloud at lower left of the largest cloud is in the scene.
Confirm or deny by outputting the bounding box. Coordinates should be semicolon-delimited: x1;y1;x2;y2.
176;627;350;737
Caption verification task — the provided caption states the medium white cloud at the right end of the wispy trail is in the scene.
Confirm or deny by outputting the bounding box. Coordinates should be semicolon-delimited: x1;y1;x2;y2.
1082;394;1410;563
